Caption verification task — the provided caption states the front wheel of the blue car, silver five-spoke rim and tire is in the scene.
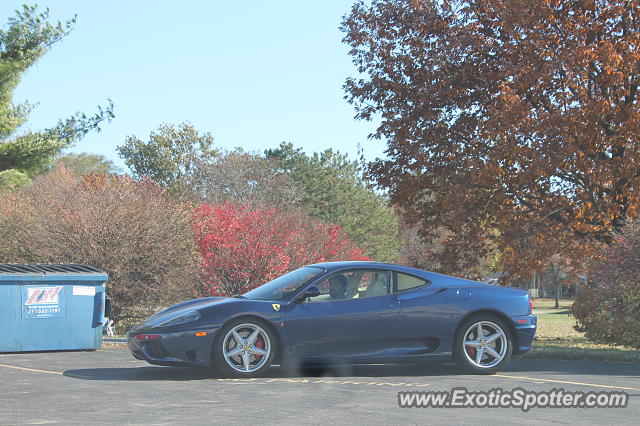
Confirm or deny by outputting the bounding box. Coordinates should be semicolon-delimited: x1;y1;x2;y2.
212;318;276;377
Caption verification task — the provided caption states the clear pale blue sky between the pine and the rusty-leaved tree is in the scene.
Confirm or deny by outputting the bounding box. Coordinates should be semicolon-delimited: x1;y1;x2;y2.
0;0;385;170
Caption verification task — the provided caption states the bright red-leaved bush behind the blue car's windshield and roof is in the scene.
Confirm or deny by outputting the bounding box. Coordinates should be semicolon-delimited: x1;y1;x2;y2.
193;203;369;295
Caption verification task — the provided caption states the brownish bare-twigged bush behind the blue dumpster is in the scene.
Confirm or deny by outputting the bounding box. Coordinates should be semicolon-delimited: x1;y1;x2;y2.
0;166;199;324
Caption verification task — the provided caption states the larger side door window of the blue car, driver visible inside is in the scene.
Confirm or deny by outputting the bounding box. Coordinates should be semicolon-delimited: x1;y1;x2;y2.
307;270;390;303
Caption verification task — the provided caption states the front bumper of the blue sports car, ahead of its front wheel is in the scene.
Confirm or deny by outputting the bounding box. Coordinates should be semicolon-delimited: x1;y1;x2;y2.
127;330;215;367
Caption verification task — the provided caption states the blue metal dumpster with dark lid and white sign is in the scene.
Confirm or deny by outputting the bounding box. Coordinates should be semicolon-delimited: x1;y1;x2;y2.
0;264;108;352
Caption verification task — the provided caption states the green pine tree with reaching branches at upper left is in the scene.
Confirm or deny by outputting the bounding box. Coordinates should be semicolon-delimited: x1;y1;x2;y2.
0;6;113;189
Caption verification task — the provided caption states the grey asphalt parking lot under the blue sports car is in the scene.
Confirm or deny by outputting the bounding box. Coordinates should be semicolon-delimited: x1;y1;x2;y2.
0;349;640;425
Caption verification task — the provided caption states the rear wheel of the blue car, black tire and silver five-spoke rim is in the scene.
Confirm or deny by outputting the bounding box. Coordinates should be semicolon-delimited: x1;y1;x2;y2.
453;314;513;374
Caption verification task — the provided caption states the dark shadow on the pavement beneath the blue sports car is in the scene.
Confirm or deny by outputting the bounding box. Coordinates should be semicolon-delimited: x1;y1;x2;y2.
63;364;465;381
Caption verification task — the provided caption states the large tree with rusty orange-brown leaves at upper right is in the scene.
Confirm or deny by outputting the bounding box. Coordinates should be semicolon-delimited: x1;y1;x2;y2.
342;0;640;273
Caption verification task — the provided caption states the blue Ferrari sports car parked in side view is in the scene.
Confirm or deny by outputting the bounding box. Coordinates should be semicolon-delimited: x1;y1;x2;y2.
128;262;536;377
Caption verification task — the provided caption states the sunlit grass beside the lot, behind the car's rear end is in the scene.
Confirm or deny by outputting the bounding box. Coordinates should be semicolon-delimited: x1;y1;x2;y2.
522;299;640;362
